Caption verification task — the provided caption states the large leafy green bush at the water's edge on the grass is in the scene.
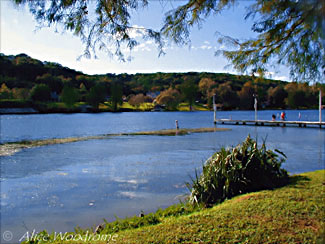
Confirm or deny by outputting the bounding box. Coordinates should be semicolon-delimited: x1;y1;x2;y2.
187;136;289;206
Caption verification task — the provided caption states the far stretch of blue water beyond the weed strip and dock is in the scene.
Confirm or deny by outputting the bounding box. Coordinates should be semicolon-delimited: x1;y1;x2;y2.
0;110;325;142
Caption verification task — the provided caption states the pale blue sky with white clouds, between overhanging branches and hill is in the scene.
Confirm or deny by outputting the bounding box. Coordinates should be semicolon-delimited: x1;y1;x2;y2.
0;0;289;80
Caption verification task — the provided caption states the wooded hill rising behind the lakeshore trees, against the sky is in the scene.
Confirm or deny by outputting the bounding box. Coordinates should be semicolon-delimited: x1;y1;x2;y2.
0;53;285;91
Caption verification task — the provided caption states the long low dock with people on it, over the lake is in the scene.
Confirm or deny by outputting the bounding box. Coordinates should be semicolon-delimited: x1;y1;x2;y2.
214;119;325;129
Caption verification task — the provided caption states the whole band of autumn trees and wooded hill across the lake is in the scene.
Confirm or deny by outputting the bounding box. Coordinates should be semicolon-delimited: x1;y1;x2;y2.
0;54;325;111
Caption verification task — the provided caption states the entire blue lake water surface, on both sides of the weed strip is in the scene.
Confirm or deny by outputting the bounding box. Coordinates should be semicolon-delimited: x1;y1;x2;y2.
0;110;325;244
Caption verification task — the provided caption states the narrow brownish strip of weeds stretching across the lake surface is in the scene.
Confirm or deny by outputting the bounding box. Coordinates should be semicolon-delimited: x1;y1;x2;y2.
0;128;230;156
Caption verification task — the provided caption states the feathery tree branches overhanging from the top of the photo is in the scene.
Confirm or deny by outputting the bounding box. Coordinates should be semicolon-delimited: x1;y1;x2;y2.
13;0;325;82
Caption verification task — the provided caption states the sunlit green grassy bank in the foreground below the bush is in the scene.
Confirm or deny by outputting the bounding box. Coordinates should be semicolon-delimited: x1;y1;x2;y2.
21;170;325;244
